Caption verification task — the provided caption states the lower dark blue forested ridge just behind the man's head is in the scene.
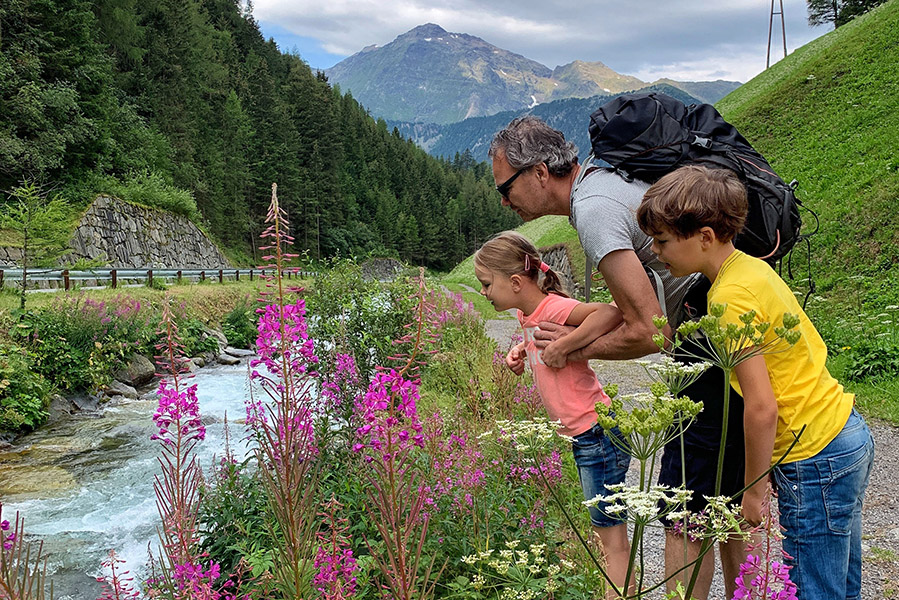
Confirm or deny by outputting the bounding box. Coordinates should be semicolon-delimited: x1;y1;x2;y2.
387;84;701;161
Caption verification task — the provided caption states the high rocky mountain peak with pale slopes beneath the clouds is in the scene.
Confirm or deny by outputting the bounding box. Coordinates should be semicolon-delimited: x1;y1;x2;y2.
325;23;740;124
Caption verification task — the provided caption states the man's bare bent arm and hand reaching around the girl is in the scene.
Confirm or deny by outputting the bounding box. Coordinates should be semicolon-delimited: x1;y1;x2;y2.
534;250;671;360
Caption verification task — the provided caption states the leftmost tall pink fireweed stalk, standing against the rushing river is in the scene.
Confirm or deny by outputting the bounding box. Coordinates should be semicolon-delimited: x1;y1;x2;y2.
151;297;219;600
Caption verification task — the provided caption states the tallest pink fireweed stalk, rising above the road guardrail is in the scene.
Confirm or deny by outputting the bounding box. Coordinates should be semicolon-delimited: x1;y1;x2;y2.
247;184;318;599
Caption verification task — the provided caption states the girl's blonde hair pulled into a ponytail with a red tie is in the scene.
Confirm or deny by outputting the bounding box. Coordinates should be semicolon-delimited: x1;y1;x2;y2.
474;231;568;298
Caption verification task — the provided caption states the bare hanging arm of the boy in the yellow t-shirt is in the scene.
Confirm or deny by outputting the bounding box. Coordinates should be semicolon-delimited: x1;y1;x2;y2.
734;355;777;527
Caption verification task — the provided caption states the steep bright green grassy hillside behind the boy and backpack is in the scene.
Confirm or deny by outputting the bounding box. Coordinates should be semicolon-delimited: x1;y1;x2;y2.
718;0;899;304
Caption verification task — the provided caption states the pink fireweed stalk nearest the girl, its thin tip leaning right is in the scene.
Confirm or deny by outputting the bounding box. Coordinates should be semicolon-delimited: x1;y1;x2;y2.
353;269;442;600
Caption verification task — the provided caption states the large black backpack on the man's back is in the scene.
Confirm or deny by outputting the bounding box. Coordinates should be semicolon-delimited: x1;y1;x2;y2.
590;93;803;264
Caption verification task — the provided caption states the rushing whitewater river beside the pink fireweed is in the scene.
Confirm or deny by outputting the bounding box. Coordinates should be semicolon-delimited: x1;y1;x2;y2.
0;360;255;600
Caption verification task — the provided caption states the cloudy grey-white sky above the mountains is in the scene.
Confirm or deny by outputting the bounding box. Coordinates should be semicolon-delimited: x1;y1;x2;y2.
253;0;832;82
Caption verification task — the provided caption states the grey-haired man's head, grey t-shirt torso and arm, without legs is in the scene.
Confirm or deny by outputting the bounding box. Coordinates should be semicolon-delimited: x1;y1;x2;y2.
488;116;693;359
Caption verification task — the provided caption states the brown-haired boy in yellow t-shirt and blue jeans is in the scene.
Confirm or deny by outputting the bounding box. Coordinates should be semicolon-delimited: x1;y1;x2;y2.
637;165;874;600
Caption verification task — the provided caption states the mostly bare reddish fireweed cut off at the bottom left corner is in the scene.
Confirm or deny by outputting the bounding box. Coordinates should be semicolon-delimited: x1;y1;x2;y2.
0;502;53;600
